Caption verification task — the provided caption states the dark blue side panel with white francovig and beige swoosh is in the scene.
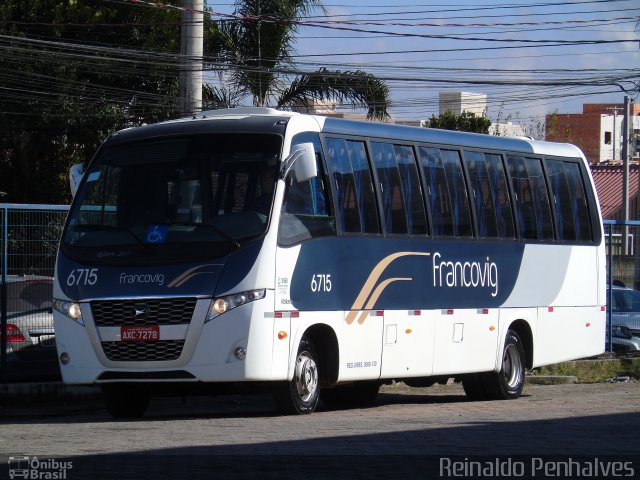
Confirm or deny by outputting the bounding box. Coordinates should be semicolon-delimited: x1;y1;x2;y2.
290;237;524;311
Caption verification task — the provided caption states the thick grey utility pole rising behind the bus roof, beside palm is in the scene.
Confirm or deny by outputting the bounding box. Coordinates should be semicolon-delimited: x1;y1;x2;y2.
179;0;204;117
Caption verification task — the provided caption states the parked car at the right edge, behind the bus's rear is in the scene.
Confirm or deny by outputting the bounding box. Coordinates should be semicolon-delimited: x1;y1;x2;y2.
607;285;640;353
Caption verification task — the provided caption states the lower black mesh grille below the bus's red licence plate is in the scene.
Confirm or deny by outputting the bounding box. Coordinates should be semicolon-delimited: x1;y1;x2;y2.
102;340;184;362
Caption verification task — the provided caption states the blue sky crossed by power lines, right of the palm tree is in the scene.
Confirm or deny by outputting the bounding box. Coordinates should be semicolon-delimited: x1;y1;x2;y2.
208;0;640;123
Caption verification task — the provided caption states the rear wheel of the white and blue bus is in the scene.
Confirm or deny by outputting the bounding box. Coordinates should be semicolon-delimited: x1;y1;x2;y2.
483;330;526;400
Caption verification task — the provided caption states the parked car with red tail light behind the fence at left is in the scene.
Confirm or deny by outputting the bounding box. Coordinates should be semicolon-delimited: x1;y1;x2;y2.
0;275;60;381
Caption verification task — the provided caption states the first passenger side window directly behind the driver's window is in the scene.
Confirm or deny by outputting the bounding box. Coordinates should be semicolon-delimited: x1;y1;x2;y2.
326;137;380;233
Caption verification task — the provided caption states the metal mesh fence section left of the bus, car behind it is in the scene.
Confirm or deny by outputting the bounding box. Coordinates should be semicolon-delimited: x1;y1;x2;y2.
0;204;69;379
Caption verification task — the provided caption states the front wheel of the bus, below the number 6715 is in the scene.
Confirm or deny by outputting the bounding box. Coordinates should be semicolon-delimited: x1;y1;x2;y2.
274;335;320;415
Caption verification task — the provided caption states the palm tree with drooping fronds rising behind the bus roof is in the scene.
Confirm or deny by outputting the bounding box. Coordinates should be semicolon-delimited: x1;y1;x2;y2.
205;0;389;119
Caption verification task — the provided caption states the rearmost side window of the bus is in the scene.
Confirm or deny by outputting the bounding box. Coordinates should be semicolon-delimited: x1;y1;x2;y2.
546;159;592;241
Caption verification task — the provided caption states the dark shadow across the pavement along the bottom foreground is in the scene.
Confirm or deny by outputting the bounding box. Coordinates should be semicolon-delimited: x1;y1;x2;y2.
0;413;640;479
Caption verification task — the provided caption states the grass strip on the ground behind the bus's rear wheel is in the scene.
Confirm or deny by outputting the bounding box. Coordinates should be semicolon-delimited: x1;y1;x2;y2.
532;358;640;383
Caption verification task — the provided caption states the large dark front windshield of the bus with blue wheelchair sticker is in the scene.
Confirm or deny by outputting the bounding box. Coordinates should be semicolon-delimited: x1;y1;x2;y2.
62;134;282;261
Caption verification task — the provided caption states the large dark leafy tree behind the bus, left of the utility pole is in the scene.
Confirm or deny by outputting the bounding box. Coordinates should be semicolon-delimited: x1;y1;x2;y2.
0;0;219;203
